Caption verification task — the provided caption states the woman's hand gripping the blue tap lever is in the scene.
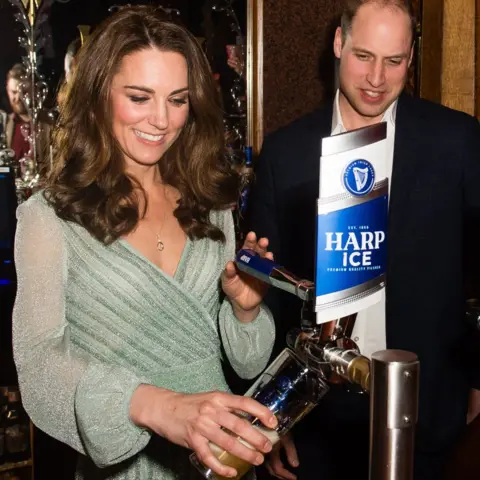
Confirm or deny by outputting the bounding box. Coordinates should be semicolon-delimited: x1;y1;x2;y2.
222;232;273;323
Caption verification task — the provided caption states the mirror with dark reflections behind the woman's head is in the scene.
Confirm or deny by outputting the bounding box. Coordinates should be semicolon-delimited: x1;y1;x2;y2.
0;0;255;225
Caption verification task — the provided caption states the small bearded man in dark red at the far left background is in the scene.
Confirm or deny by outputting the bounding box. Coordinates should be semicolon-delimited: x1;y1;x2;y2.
0;63;50;174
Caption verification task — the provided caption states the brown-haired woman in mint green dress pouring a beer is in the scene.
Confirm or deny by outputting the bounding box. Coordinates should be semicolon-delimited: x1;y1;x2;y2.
14;7;276;480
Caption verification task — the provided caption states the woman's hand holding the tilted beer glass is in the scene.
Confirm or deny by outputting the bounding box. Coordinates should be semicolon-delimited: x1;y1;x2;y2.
130;385;277;477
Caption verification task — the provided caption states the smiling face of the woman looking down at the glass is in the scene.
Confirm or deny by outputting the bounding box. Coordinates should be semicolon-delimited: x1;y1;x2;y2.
111;48;189;168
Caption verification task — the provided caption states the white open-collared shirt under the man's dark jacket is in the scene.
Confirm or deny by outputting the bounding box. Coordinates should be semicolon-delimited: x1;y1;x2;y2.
332;90;397;358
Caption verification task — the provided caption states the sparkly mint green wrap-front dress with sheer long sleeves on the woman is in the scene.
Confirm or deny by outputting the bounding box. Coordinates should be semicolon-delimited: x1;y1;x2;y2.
13;193;275;480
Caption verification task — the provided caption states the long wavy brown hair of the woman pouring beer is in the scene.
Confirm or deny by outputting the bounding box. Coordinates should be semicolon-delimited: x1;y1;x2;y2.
44;6;239;244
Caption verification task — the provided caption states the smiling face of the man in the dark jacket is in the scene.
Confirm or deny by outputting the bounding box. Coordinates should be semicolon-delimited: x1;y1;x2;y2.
334;3;413;126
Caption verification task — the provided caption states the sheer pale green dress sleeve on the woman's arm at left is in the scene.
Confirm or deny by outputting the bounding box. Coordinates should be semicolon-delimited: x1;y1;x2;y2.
13;195;151;466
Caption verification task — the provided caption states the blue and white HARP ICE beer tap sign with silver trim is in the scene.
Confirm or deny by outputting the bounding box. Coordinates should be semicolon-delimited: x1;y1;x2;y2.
315;122;389;324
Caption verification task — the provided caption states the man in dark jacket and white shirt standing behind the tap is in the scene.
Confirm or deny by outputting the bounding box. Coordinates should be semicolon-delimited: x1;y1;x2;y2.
249;0;480;480
